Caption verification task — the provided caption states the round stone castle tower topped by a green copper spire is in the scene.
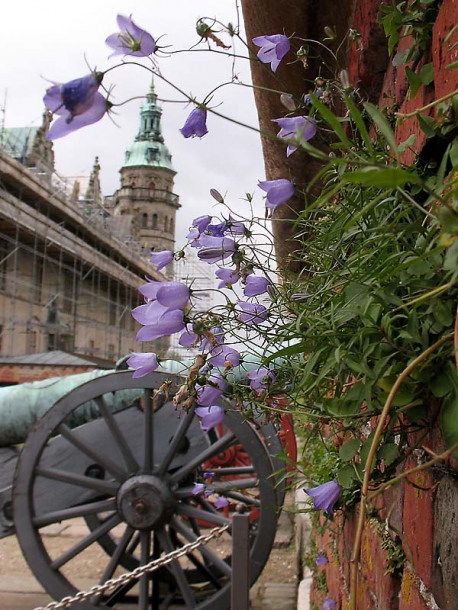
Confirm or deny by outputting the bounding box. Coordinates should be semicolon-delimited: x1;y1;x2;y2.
113;78;180;256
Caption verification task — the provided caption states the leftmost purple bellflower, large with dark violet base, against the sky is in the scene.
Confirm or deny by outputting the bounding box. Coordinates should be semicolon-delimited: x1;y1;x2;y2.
43;72;111;140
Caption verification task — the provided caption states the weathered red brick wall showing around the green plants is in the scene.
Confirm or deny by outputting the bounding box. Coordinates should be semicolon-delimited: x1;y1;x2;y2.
311;0;458;610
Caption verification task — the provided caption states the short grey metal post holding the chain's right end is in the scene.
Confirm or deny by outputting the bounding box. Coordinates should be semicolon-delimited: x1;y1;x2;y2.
231;506;250;610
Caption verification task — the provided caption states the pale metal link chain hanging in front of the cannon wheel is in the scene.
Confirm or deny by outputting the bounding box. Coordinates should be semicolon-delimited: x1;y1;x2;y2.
34;525;229;610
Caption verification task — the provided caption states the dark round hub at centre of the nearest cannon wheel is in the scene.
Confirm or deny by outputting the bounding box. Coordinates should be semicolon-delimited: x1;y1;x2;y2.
117;475;176;530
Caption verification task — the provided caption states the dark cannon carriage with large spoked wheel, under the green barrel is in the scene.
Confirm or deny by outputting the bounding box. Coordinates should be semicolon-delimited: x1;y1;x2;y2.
0;364;291;610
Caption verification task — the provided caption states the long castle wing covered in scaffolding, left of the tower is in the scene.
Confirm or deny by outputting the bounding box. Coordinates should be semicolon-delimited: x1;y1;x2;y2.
0;137;168;362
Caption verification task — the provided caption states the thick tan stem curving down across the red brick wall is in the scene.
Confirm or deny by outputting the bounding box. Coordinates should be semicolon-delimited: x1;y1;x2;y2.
349;333;453;610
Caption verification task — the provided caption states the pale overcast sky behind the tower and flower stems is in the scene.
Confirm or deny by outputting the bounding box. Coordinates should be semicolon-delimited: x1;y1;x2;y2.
0;0;264;246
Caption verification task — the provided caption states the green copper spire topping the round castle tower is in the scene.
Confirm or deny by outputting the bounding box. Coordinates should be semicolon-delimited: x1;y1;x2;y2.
123;81;175;172
